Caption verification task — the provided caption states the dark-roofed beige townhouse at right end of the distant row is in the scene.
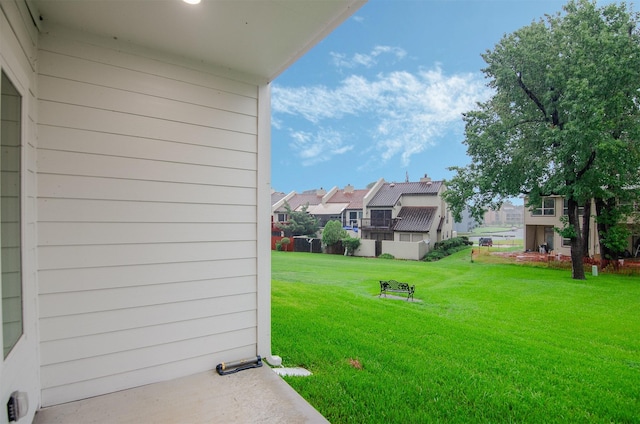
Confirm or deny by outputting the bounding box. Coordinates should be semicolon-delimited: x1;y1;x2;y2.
361;176;453;247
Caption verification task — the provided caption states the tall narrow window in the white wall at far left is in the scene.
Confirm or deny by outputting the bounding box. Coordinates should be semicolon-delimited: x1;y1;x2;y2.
0;72;23;358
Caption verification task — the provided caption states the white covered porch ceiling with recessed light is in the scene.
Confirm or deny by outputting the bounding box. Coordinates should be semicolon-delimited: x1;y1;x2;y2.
25;0;366;82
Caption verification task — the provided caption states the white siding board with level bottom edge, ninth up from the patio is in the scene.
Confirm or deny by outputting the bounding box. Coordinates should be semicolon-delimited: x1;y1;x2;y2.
38;198;257;223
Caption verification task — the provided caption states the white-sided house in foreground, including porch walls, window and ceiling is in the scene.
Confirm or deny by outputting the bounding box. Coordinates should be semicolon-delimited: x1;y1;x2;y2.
0;0;363;422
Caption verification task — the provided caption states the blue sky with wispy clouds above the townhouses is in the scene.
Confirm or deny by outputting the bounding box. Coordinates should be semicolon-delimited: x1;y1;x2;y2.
271;0;580;193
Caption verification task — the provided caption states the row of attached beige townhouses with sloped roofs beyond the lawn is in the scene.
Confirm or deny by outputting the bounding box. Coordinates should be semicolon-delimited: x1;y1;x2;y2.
272;176;454;259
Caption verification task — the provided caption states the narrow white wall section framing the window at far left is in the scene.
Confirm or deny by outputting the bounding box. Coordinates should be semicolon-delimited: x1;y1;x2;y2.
0;1;40;424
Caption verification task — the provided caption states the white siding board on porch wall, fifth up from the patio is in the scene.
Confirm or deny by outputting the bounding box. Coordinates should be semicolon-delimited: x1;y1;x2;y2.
40;276;256;318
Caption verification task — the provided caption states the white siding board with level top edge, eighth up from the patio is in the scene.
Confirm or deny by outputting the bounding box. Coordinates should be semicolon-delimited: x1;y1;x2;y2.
38;222;256;246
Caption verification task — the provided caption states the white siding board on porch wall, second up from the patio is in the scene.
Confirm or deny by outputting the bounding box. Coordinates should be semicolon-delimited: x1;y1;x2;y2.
41;328;256;387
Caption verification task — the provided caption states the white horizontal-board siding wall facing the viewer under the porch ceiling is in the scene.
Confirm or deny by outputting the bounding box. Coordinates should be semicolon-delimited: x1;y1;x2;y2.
38;31;258;406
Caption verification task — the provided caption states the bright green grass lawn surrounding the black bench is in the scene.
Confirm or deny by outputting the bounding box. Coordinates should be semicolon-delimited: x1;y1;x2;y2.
272;250;640;424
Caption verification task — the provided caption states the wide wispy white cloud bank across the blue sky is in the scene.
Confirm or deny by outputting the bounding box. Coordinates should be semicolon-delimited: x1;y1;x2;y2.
272;66;490;166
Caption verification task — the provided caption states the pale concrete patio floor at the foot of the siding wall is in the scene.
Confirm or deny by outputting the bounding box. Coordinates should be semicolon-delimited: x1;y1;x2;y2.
33;364;328;424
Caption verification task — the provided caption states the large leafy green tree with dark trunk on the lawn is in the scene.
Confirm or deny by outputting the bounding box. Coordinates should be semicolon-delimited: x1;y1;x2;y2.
445;0;640;279
